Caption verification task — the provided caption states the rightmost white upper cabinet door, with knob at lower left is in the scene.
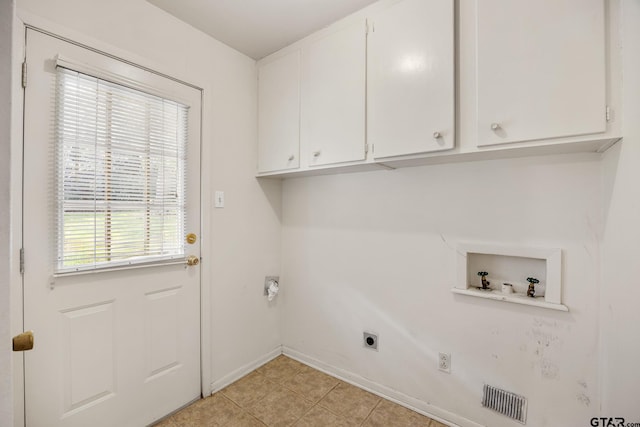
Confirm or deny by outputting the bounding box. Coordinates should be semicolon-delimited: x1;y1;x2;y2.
477;0;606;146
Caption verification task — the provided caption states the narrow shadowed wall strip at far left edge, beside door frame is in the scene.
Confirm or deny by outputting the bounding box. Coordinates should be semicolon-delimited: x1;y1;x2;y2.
0;0;14;426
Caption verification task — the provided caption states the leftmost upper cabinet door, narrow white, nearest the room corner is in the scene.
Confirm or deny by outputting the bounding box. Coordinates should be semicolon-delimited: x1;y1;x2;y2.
258;51;300;172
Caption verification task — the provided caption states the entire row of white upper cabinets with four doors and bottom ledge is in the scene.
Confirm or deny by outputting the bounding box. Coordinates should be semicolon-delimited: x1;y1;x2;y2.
258;0;622;176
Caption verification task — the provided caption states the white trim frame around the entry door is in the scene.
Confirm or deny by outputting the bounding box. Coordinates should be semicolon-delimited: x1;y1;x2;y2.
10;15;212;427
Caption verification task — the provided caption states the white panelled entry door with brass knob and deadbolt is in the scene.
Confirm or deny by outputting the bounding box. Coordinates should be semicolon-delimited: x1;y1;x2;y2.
23;30;201;427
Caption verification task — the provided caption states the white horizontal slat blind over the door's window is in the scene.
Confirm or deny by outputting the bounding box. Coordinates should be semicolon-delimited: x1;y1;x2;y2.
55;67;188;273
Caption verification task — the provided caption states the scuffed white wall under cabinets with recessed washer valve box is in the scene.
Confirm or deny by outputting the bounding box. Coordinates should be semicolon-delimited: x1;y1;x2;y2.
282;155;602;427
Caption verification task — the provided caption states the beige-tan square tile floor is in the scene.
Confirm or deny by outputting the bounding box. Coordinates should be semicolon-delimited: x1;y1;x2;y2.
154;356;446;427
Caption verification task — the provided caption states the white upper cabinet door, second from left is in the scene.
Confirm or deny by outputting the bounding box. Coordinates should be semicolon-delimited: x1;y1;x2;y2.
301;19;366;166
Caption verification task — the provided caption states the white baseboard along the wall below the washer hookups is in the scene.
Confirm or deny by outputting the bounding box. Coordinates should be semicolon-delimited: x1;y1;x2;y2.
282;346;484;427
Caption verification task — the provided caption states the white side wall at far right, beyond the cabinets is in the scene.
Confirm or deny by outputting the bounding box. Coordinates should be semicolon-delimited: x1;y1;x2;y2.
601;0;640;422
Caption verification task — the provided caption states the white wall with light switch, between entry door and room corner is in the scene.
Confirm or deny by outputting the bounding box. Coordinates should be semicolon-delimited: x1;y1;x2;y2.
17;0;281;398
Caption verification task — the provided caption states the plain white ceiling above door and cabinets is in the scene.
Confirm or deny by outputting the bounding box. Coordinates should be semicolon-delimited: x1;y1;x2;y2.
147;0;376;59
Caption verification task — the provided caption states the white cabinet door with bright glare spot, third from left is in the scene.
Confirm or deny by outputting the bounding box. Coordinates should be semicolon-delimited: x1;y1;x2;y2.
367;0;455;159
